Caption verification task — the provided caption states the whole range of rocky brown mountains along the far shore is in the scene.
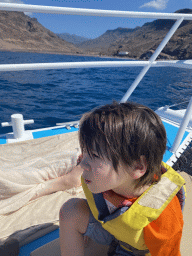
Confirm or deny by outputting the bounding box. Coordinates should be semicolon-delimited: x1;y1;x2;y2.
0;9;192;60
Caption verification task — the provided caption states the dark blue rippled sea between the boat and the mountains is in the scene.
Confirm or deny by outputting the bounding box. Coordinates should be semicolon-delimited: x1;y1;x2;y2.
0;52;192;134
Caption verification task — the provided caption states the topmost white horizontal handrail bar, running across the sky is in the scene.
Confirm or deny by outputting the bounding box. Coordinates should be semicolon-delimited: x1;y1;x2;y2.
0;3;192;20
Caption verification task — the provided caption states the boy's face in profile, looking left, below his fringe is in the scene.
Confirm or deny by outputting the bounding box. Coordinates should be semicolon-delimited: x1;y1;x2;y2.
80;152;129;193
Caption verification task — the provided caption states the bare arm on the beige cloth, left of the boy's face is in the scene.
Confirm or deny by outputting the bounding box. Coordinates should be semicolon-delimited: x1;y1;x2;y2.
31;165;83;200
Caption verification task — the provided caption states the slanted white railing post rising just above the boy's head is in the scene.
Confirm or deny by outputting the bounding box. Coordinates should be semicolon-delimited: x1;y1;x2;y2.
120;17;184;102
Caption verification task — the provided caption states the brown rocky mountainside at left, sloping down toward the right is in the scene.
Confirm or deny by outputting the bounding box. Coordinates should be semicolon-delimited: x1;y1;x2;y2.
0;11;84;54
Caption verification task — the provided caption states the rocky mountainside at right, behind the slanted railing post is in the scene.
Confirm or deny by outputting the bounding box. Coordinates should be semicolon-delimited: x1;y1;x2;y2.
78;9;192;59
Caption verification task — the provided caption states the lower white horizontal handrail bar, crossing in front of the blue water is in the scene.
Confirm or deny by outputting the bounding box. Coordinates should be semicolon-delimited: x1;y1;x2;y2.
0;60;192;72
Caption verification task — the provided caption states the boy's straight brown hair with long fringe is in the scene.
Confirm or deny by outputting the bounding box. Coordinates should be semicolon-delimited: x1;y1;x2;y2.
79;102;167;188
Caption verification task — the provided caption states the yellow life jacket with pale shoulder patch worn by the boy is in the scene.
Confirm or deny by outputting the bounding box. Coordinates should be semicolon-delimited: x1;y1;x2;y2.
82;163;186;256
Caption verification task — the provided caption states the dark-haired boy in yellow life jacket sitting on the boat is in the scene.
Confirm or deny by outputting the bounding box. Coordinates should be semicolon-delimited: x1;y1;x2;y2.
60;102;185;256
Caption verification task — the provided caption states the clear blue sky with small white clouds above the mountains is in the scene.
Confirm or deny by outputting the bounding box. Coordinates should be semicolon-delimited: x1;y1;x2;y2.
0;0;192;39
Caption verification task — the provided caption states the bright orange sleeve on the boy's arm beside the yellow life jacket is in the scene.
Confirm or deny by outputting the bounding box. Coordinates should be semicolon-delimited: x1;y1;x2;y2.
144;196;183;256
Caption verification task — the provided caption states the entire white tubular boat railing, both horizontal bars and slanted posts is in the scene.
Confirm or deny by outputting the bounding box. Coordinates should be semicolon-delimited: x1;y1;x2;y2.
0;3;192;152
